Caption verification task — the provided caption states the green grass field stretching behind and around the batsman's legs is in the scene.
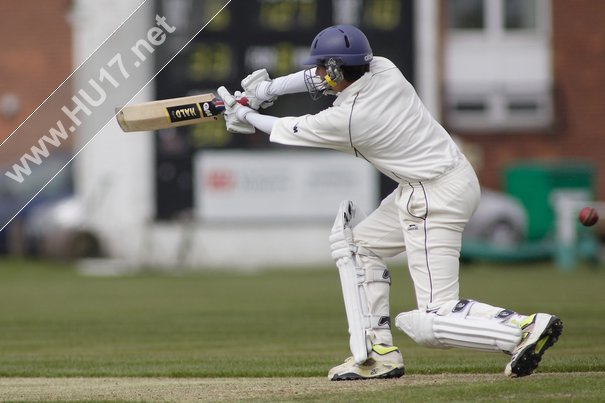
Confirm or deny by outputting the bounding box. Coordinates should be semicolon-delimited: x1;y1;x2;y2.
0;260;605;401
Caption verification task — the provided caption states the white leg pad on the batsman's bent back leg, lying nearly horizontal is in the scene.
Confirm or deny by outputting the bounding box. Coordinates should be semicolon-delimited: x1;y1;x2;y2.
395;310;521;352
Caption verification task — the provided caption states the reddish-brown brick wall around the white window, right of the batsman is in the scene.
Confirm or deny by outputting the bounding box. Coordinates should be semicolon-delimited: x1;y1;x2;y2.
452;0;605;200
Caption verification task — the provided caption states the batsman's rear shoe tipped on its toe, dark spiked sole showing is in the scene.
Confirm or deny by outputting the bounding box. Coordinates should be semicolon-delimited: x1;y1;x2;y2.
504;313;563;378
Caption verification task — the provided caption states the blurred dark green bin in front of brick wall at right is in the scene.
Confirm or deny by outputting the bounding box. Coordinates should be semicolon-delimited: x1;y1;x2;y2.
505;160;595;241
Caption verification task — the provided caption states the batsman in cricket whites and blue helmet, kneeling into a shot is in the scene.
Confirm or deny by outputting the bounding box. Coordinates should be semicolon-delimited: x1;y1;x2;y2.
218;25;563;381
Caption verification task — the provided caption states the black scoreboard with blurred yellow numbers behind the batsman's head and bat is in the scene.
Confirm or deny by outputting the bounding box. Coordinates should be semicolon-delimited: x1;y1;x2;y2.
155;0;414;220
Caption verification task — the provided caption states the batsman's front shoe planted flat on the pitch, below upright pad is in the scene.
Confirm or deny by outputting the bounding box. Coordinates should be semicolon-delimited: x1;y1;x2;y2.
328;344;404;381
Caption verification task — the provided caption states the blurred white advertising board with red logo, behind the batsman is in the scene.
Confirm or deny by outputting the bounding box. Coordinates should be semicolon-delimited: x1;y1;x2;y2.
194;150;379;222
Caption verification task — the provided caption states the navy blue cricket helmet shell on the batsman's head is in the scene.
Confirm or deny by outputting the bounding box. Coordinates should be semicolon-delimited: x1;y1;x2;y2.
303;25;373;66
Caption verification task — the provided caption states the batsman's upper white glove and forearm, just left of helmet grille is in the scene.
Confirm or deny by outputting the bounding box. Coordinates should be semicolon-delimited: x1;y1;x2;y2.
242;69;314;109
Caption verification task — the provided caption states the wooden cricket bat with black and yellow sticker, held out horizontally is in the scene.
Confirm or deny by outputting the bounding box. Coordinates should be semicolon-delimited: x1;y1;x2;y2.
116;93;248;132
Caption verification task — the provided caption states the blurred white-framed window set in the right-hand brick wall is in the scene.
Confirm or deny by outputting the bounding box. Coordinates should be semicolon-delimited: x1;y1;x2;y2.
443;0;552;132
